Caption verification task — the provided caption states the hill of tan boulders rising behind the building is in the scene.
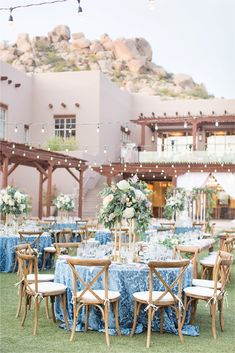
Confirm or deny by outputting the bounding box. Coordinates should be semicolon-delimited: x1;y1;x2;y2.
0;25;210;99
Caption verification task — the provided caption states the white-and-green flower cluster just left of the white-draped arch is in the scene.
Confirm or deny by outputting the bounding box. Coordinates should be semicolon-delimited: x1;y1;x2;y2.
165;188;187;219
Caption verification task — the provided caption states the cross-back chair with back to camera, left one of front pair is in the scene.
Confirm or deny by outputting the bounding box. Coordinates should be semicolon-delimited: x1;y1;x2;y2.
67;258;120;346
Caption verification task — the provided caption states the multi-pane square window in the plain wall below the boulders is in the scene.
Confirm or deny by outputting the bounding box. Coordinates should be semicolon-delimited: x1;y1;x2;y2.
54;115;76;139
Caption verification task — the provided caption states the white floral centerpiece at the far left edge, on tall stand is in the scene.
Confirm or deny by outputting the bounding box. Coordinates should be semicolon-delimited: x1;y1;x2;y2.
0;186;29;216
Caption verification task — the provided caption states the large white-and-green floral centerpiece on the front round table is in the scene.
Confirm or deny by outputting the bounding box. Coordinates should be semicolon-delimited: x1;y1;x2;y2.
98;176;152;235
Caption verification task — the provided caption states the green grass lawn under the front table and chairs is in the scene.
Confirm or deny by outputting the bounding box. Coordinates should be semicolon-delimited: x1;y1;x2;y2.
0;264;235;353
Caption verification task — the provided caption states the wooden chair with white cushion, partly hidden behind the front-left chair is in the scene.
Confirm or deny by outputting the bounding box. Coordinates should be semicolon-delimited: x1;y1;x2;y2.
15;244;55;319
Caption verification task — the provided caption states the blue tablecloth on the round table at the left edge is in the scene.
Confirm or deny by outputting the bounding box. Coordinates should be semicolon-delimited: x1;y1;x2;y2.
0;233;51;272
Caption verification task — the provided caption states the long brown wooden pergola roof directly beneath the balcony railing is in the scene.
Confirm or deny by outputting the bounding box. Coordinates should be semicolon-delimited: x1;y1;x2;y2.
93;162;235;186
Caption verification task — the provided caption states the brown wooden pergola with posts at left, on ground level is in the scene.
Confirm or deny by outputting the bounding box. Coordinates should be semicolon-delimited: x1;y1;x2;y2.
0;141;88;219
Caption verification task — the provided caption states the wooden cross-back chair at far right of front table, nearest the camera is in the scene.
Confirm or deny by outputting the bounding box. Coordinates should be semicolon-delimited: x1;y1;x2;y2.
184;251;233;339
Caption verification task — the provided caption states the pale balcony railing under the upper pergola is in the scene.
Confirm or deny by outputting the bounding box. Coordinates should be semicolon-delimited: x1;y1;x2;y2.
121;143;235;164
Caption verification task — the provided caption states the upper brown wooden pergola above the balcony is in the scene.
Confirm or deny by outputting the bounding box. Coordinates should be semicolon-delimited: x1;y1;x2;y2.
131;111;235;150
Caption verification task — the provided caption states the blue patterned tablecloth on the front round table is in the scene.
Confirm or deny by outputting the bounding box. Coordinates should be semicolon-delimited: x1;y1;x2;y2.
55;260;199;336
